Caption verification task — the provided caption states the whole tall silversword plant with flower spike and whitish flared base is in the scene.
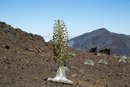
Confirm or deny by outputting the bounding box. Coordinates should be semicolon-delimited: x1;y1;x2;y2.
48;19;73;84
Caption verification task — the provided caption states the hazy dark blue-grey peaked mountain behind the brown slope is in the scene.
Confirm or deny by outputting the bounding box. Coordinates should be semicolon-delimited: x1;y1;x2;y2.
69;28;130;56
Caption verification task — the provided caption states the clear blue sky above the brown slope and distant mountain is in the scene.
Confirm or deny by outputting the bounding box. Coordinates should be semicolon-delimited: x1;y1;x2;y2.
0;0;130;35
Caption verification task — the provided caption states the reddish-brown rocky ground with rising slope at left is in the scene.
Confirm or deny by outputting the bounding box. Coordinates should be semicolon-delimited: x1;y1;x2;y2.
0;22;130;87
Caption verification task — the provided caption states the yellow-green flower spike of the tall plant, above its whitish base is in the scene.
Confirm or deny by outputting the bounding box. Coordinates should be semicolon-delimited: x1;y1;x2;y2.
53;19;68;66
